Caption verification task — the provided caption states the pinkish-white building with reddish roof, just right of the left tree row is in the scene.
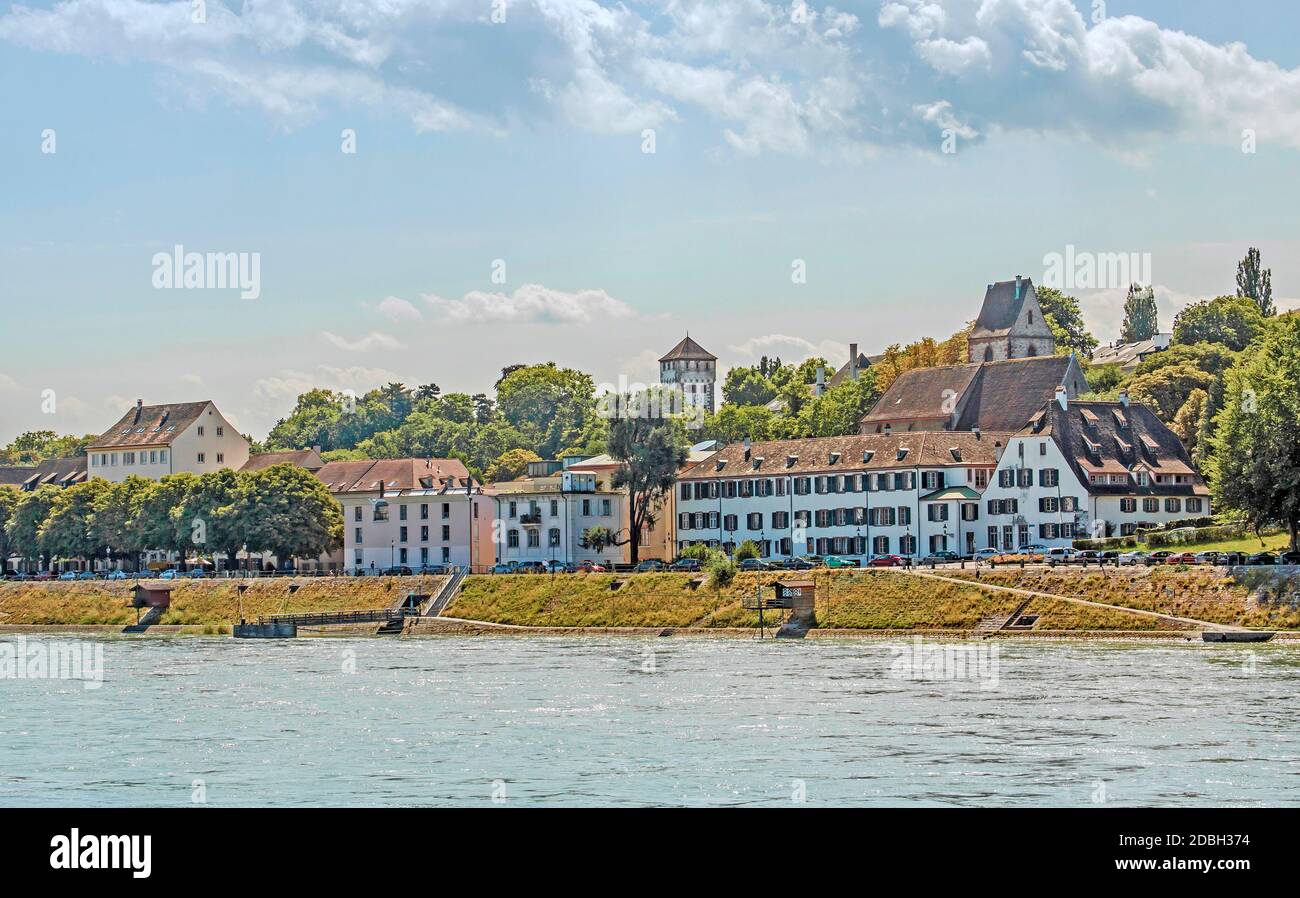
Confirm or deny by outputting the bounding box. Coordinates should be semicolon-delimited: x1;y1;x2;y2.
316;459;493;574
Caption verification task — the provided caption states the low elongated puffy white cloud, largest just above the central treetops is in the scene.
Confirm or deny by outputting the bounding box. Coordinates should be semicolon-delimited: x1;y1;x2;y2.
424;283;636;325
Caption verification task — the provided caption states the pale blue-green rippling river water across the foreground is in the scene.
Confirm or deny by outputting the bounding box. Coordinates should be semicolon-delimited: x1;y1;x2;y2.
0;637;1300;806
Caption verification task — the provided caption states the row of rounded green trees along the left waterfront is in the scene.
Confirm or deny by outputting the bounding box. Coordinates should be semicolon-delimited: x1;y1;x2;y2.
0;464;343;569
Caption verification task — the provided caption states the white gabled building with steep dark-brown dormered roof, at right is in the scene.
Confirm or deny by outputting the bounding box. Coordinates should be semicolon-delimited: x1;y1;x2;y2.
982;390;1210;548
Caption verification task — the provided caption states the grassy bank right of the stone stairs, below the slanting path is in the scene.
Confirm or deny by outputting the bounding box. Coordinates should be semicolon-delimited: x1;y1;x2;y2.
443;571;1170;630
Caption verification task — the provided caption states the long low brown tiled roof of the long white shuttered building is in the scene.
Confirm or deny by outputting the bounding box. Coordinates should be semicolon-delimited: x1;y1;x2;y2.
679;430;1011;480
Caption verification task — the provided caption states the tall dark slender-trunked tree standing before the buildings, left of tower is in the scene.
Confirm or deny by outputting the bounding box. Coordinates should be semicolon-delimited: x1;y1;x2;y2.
610;398;686;564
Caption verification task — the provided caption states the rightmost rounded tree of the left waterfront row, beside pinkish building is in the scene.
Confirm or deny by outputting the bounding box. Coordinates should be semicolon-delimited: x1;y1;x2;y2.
243;464;343;565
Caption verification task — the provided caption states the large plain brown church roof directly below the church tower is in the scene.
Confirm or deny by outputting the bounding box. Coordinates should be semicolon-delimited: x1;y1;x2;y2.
862;356;1073;433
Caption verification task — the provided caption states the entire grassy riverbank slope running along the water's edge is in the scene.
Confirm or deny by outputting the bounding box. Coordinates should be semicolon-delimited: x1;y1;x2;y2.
0;568;1300;639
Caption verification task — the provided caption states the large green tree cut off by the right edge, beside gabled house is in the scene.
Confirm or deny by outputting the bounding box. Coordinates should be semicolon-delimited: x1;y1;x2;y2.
1209;314;1300;550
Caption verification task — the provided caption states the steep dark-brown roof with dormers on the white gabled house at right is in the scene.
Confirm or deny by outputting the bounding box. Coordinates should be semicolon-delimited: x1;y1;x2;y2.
1019;400;1209;495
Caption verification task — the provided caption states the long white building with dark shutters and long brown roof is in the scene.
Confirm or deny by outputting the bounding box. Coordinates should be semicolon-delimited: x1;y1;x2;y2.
673;431;1010;560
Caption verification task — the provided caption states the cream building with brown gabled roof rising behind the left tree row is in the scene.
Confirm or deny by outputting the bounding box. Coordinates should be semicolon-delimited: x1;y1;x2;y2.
86;400;248;482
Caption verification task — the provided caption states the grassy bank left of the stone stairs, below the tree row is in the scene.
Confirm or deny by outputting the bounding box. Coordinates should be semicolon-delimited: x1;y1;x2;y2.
0;577;442;632
